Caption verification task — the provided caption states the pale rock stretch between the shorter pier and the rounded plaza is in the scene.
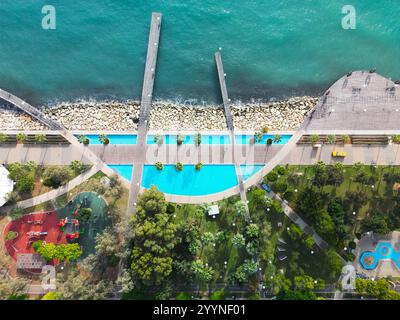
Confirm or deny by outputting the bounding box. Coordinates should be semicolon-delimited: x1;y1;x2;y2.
231;97;318;130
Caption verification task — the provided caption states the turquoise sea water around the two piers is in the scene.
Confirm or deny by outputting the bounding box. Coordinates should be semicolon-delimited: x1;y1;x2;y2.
0;0;400;104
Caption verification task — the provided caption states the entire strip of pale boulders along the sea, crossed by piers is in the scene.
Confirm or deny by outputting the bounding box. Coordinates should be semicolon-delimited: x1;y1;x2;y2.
0;96;318;132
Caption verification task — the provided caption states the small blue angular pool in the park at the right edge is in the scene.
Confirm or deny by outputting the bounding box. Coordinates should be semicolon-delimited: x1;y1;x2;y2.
360;241;400;270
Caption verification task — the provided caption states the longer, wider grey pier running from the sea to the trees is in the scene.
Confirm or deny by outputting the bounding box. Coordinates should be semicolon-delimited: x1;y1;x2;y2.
127;12;162;214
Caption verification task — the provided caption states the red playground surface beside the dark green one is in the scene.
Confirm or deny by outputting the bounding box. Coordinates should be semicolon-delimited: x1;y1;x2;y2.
3;211;67;260
